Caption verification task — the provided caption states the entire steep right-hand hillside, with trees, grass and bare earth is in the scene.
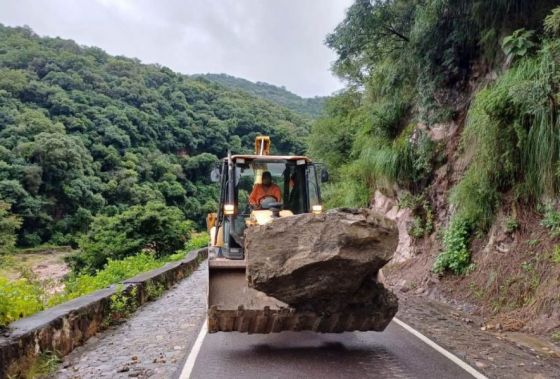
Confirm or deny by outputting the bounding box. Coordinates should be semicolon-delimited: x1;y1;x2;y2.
310;0;560;342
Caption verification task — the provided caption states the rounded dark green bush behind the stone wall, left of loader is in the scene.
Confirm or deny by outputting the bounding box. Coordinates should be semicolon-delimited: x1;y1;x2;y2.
73;202;192;272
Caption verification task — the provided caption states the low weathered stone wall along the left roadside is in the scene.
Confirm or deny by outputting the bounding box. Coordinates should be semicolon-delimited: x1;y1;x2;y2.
0;248;208;378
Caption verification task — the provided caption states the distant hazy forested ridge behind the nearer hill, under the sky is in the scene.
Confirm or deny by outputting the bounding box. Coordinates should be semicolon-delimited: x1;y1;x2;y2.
196;74;327;118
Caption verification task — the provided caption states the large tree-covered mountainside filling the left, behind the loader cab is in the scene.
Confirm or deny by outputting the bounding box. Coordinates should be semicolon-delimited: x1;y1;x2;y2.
0;25;309;262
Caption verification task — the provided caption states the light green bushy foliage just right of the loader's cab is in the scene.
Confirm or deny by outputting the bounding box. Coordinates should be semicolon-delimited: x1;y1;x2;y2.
309;83;438;206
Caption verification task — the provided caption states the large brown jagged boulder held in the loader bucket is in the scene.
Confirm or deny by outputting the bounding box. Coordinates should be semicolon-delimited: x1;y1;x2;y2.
245;209;398;323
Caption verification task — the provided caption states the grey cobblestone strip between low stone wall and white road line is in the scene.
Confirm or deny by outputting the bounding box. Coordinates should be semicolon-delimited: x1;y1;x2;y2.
52;262;207;379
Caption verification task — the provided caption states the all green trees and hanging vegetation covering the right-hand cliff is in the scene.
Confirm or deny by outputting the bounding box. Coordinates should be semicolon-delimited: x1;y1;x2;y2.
309;0;560;274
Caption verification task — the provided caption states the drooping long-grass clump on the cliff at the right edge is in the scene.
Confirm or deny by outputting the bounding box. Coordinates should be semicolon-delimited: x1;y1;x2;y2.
464;25;560;199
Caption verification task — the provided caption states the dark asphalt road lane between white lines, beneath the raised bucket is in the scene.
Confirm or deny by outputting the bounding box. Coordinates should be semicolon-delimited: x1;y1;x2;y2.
186;323;472;379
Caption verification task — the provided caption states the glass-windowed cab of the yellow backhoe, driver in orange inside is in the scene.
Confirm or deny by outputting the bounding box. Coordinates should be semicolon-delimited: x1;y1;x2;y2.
207;137;327;260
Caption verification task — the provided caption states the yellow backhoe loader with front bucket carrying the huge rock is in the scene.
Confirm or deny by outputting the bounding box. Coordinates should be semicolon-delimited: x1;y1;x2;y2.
207;137;384;333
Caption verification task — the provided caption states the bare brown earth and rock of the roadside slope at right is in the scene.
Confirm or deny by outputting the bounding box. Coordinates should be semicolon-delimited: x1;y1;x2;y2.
378;107;560;350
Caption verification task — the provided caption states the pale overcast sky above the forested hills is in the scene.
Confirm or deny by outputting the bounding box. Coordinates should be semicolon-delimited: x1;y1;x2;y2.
0;0;352;97
